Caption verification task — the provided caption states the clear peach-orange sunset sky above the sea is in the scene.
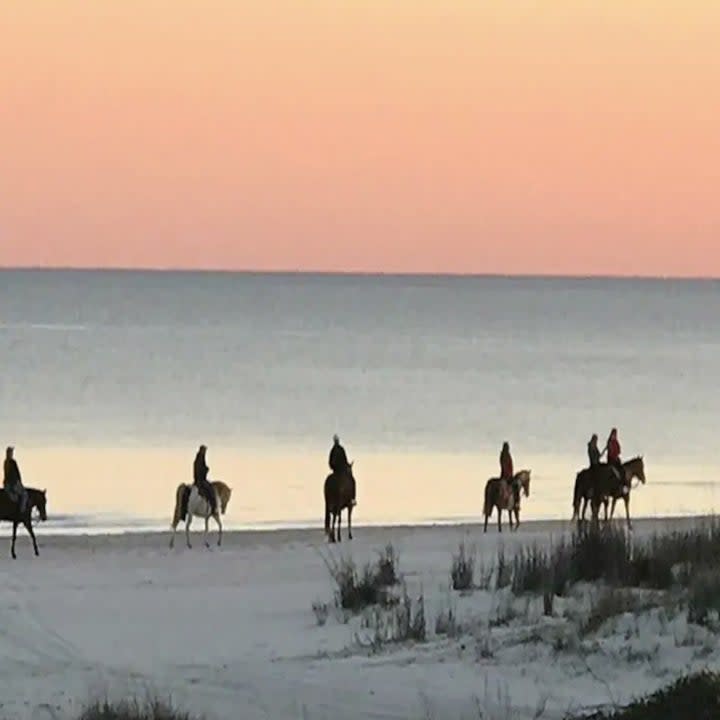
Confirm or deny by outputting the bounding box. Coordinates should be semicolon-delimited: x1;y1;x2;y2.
0;0;720;277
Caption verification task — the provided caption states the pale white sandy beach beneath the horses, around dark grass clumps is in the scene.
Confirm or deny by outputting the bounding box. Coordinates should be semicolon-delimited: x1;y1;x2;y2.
0;519;720;720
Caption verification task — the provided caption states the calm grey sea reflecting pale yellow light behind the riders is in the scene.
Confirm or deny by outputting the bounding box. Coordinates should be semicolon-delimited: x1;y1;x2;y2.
0;271;720;531
